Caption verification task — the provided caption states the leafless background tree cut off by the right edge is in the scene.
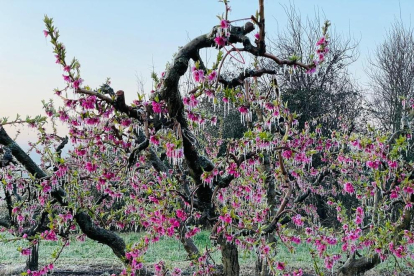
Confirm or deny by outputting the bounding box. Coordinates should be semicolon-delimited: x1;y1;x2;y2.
367;20;414;133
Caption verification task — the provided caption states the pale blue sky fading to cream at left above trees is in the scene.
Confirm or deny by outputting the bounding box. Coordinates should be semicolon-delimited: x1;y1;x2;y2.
0;0;414;147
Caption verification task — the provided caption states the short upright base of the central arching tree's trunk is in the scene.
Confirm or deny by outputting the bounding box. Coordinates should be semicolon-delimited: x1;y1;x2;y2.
220;238;240;276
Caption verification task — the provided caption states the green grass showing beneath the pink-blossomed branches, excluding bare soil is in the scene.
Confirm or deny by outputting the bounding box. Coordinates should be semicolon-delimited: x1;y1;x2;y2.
0;231;412;273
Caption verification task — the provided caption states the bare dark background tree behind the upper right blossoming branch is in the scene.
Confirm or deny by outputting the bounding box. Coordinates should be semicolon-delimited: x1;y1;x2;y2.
270;5;362;134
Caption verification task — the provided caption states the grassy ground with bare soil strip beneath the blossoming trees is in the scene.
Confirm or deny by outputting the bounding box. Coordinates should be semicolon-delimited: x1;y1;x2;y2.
0;231;414;276
